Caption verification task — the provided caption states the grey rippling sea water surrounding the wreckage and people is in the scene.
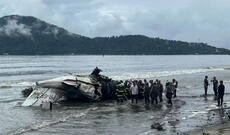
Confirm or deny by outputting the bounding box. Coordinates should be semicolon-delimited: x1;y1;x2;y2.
0;55;230;135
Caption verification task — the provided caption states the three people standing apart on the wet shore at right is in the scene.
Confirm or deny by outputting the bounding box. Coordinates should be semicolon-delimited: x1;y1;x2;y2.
204;76;225;106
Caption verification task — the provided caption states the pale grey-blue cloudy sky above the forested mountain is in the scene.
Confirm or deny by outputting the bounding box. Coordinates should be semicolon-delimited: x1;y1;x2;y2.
0;0;230;49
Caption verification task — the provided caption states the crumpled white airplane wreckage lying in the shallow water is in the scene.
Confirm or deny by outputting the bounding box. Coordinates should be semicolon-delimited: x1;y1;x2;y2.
22;67;121;106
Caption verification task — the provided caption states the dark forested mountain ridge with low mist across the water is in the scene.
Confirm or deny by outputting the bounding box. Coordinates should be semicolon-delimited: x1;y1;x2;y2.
0;15;230;55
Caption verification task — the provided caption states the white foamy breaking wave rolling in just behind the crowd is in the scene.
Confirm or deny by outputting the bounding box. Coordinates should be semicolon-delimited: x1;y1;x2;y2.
112;67;225;80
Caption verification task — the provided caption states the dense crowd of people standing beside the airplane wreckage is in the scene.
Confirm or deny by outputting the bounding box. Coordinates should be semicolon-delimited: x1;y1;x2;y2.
116;79;178;105
